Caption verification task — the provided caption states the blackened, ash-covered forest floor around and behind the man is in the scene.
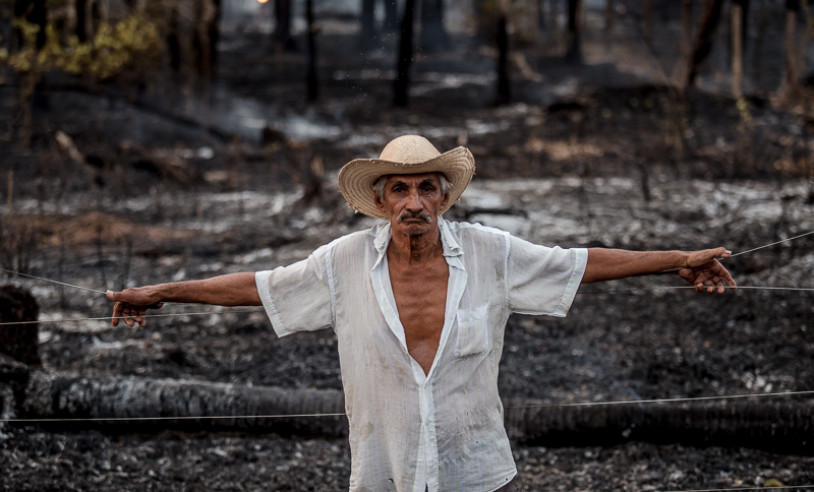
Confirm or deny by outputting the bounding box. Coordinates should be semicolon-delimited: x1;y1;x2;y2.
0;13;814;491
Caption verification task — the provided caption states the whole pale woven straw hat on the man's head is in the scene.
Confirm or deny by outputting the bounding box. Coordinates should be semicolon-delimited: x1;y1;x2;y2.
337;135;475;220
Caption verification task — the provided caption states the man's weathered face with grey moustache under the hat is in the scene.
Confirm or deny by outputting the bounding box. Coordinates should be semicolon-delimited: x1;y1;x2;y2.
376;173;449;236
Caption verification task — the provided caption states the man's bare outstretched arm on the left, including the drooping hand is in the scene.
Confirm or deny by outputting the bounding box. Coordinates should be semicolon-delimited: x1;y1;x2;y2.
107;272;262;326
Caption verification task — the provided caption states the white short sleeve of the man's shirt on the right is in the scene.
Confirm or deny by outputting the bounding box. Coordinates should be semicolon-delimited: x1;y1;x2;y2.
506;236;588;316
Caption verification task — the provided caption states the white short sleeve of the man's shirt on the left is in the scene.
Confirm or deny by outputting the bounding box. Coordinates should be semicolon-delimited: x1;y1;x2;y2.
254;247;333;337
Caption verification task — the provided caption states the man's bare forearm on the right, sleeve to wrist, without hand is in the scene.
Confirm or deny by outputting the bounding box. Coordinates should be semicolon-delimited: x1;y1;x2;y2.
582;248;689;284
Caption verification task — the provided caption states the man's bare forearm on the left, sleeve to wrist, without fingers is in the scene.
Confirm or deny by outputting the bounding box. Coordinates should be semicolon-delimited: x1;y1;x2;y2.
144;272;262;306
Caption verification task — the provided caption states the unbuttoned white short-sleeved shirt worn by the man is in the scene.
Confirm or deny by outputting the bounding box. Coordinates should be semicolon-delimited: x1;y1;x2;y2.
255;218;588;492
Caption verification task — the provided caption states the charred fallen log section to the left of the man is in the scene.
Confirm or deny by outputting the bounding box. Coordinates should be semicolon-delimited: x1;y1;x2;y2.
18;372;347;436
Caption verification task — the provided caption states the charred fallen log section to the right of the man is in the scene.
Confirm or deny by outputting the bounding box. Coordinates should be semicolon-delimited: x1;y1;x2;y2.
506;399;814;454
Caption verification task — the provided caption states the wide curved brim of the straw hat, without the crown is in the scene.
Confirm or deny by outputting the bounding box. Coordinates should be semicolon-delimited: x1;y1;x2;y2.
337;147;475;220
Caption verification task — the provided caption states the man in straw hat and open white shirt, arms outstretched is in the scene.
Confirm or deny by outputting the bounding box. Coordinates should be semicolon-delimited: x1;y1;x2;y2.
108;135;735;492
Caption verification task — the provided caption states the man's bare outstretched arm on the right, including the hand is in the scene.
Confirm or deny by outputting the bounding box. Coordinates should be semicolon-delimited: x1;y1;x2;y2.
582;248;736;294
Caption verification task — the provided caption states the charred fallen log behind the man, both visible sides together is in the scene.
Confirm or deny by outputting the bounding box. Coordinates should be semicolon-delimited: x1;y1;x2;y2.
12;371;814;454
